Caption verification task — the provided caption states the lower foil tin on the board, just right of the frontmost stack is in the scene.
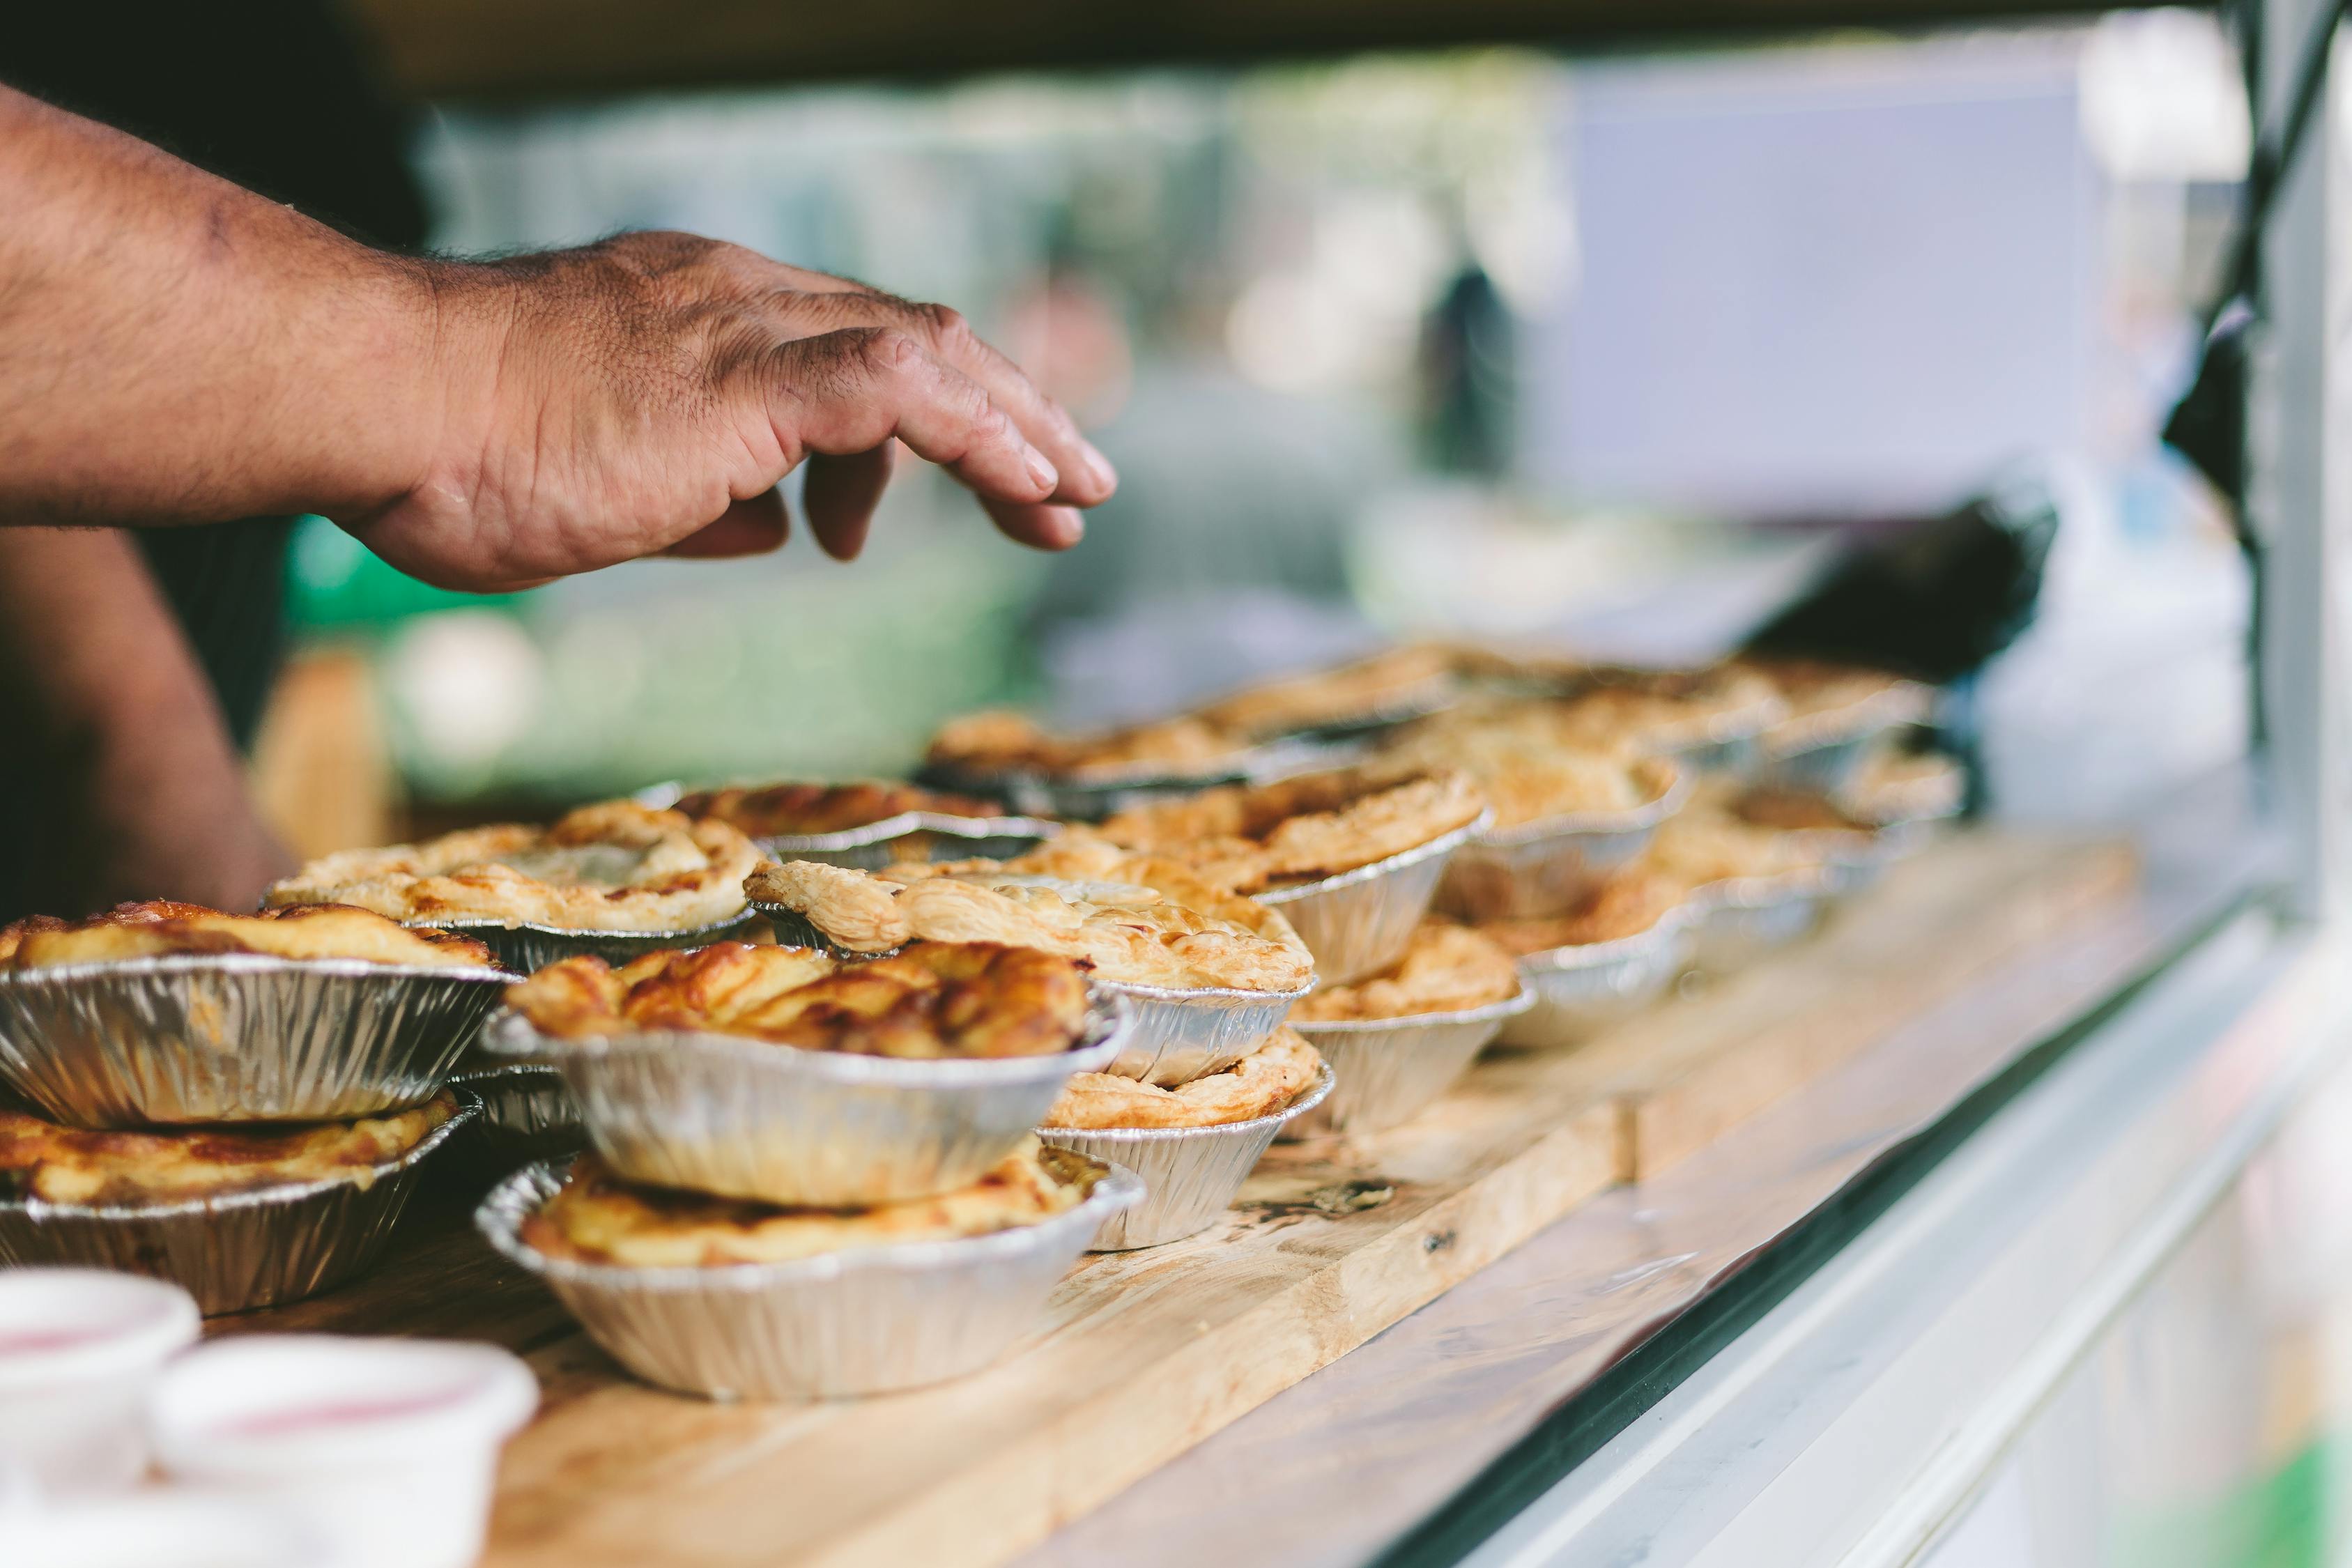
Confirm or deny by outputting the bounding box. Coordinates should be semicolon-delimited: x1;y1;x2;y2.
1037;1063;1334;1253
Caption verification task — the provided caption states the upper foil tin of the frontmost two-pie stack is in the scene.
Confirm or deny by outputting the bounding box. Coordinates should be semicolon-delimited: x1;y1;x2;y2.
482;987;1131;1208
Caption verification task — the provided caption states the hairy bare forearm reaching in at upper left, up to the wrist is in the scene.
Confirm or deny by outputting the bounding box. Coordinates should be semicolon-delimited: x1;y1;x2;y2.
0;87;449;524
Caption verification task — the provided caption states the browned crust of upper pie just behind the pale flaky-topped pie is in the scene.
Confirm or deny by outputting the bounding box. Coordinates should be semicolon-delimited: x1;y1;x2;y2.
1077;769;1486;893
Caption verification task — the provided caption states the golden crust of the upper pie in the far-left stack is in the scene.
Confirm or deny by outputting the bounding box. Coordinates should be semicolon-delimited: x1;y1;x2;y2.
0;898;496;969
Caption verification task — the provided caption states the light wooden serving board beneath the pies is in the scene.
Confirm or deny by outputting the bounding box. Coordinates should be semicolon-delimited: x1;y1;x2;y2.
217;835;2131;1568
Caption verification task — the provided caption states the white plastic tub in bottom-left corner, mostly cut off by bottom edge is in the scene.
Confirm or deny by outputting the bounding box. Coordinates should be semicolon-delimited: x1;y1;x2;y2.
0;1488;334;1568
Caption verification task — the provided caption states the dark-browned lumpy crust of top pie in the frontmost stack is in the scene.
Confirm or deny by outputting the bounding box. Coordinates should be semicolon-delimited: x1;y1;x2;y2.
506;943;1086;1058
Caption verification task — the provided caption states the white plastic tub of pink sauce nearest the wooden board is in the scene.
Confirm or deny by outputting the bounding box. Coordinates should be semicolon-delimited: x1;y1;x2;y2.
151;1335;539;1568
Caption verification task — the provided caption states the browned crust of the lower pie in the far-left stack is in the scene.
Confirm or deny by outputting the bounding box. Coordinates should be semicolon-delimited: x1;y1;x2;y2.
0;1093;456;1204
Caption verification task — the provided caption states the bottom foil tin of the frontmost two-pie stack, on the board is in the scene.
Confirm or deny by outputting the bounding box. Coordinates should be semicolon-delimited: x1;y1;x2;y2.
475;1152;1143;1399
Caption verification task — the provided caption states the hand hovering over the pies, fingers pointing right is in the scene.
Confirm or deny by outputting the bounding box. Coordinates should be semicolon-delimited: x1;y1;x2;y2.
339;233;1117;590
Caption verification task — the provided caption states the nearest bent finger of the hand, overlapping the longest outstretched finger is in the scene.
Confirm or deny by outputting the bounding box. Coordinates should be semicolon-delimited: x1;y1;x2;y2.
767;327;1061;503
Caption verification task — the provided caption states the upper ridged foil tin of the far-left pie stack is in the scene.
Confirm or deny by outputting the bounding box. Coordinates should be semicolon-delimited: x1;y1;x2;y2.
0;952;513;1128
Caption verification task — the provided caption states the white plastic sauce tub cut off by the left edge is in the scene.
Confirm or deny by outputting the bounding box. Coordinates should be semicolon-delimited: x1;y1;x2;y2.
0;1270;200;1495
